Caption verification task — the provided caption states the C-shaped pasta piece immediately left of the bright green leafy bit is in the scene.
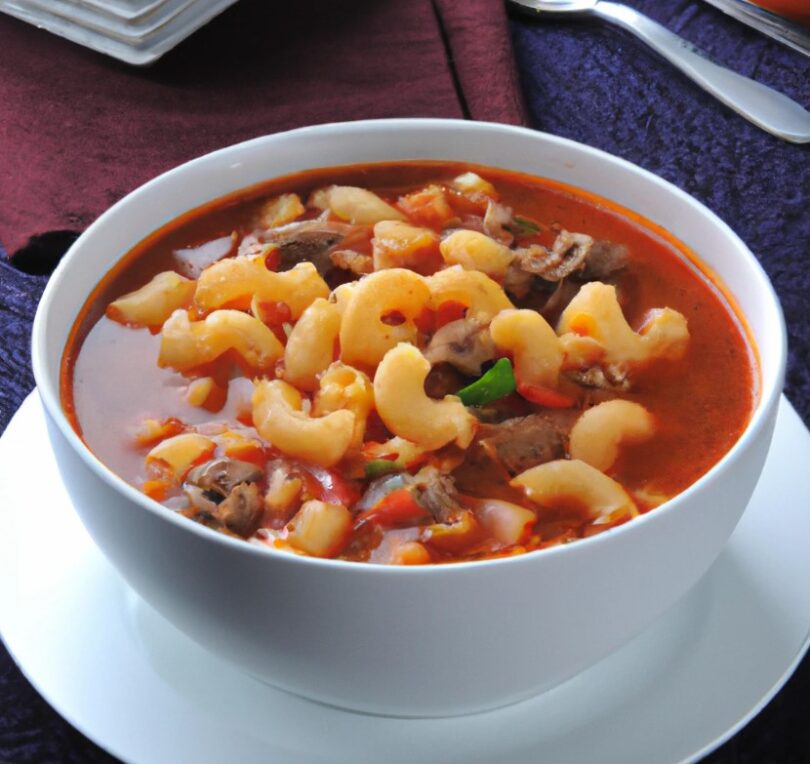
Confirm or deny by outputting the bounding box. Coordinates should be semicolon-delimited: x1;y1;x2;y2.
374;343;476;450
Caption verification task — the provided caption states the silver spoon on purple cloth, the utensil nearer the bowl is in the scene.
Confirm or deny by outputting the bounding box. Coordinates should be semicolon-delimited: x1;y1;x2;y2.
507;0;810;143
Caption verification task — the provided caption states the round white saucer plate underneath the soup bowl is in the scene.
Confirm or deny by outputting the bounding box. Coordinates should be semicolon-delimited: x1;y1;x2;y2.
0;394;810;764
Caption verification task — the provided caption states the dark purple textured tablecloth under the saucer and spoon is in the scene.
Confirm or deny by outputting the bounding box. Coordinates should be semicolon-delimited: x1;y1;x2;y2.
0;0;810;764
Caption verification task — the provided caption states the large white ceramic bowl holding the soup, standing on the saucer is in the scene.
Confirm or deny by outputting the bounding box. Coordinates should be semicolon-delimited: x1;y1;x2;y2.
33;120;785;716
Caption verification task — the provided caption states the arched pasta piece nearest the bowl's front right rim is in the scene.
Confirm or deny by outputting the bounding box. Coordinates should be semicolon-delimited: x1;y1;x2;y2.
509;459;638;523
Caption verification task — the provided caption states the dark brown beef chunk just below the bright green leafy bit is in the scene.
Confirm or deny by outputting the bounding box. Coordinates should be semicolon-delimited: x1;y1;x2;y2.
466;414;567;477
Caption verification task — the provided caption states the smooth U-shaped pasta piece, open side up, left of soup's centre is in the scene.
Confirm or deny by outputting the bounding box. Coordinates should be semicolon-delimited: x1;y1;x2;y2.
253;379;354;467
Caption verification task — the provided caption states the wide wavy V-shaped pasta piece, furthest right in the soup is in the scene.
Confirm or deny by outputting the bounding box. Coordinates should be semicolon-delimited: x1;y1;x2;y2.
557;281;689;363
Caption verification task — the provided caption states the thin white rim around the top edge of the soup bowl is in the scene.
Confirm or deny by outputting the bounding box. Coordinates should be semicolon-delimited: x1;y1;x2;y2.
31;118;787;576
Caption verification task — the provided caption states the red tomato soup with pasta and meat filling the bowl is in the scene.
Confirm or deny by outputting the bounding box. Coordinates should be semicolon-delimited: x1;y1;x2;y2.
61;162;759;564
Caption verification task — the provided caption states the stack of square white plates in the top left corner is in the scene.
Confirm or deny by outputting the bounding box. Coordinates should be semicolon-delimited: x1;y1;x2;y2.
0;0;236;66
